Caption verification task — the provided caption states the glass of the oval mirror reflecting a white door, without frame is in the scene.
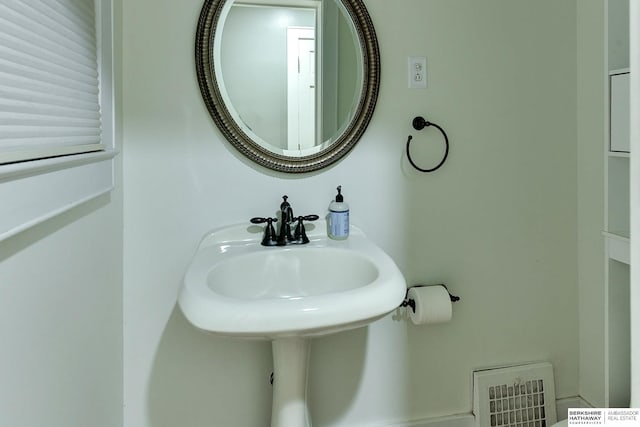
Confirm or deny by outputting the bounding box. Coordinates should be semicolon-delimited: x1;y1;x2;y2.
214;0;362;155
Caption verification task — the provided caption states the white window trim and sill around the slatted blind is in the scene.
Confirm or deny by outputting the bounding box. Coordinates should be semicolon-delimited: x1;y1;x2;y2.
0;0;118;241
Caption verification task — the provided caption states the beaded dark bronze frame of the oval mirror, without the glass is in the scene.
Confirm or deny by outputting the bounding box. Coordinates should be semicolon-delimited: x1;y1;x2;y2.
195;0;380;173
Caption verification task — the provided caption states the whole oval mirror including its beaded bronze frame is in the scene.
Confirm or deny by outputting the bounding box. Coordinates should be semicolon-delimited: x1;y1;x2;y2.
196;0;380;173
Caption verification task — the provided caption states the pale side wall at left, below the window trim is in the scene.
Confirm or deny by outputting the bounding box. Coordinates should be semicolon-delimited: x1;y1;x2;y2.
0;196;122;427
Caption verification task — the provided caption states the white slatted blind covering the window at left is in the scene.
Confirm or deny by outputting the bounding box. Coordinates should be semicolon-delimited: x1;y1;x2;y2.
0;0;105;164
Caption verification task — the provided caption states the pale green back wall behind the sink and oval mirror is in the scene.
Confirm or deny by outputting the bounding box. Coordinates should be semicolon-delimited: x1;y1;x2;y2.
122;0;578;427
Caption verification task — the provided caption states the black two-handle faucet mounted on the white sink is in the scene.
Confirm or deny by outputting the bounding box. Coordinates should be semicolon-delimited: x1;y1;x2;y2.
250;195;320;246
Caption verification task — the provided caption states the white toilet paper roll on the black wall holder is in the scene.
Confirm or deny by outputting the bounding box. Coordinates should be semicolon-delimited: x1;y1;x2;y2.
407;285;453;325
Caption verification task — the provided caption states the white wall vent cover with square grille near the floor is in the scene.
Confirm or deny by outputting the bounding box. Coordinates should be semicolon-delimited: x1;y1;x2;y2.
473;363;557;427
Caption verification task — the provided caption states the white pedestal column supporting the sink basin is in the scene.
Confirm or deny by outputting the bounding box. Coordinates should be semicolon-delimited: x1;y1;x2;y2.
271;337;311;427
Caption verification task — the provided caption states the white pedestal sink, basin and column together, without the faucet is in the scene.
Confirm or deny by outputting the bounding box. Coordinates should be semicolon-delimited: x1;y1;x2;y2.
178;221;406;427
